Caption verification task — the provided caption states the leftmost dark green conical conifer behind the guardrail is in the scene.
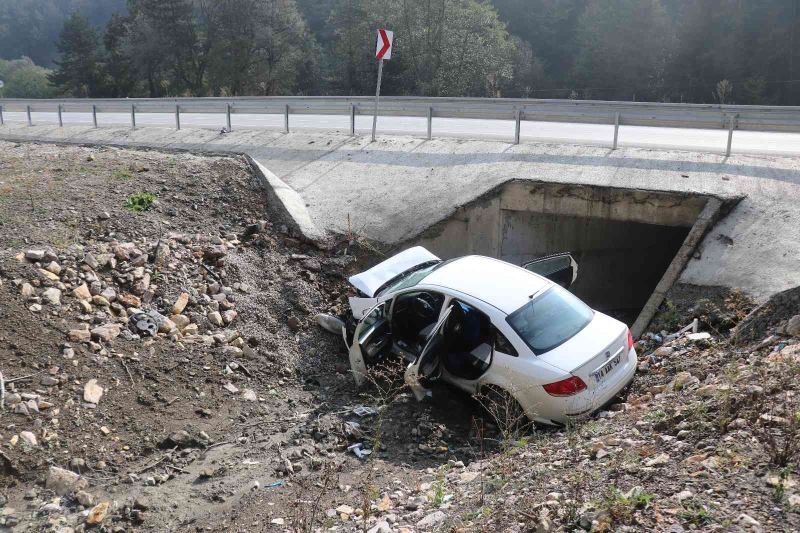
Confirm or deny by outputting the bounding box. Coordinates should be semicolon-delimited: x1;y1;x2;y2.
49;13;102;97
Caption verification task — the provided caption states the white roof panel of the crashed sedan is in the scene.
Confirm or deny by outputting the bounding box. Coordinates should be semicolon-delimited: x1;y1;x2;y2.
422;255;552;314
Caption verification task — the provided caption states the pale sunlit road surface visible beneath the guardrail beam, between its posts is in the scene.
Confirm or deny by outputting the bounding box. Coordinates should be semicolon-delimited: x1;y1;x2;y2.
5;112;800;155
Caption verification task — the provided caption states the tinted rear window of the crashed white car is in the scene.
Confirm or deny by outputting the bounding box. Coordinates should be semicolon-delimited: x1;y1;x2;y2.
506;285;594;355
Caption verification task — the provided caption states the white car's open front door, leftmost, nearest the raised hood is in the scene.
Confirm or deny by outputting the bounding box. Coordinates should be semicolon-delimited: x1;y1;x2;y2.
350;300;392;387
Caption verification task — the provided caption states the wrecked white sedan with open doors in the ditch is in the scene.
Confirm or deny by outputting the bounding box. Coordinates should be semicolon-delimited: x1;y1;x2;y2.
334;247;636;424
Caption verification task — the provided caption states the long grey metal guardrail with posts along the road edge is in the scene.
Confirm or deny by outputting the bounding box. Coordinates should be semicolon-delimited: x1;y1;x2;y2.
0;96;800;155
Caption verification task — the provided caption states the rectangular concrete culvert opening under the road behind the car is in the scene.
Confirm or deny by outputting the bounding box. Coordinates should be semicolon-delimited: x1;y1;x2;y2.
413;181;720;325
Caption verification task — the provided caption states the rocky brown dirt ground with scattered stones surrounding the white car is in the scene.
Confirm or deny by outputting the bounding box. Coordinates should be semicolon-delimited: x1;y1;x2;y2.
0;139;800;533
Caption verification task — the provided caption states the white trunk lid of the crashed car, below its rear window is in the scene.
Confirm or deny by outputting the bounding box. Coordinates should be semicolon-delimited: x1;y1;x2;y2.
539;312;628;390
